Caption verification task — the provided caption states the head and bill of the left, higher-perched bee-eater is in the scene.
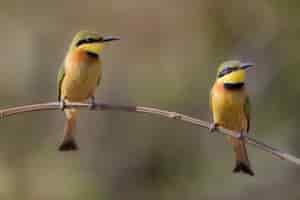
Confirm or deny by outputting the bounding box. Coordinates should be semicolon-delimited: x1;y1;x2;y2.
70;31;120;55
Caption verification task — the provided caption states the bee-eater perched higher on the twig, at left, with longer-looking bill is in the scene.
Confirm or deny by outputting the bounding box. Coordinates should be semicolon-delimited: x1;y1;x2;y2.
57;31;119;151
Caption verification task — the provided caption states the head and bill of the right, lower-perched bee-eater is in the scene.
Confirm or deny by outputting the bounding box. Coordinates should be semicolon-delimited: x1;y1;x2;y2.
217;60;254;85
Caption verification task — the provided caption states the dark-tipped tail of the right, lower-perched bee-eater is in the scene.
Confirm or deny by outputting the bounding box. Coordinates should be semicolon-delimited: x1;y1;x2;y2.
231;138;254;176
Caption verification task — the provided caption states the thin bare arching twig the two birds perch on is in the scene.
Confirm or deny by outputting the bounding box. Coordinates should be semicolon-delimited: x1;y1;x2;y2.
0;102;300;166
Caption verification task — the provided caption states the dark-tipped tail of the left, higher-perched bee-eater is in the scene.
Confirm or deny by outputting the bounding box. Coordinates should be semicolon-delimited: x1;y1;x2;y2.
59;109;78;151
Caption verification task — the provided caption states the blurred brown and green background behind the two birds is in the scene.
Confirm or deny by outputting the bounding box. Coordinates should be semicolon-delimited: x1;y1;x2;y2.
0;0;300;200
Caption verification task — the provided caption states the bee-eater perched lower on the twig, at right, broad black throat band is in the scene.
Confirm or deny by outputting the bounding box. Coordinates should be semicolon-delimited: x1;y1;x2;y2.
210;61;254;176
